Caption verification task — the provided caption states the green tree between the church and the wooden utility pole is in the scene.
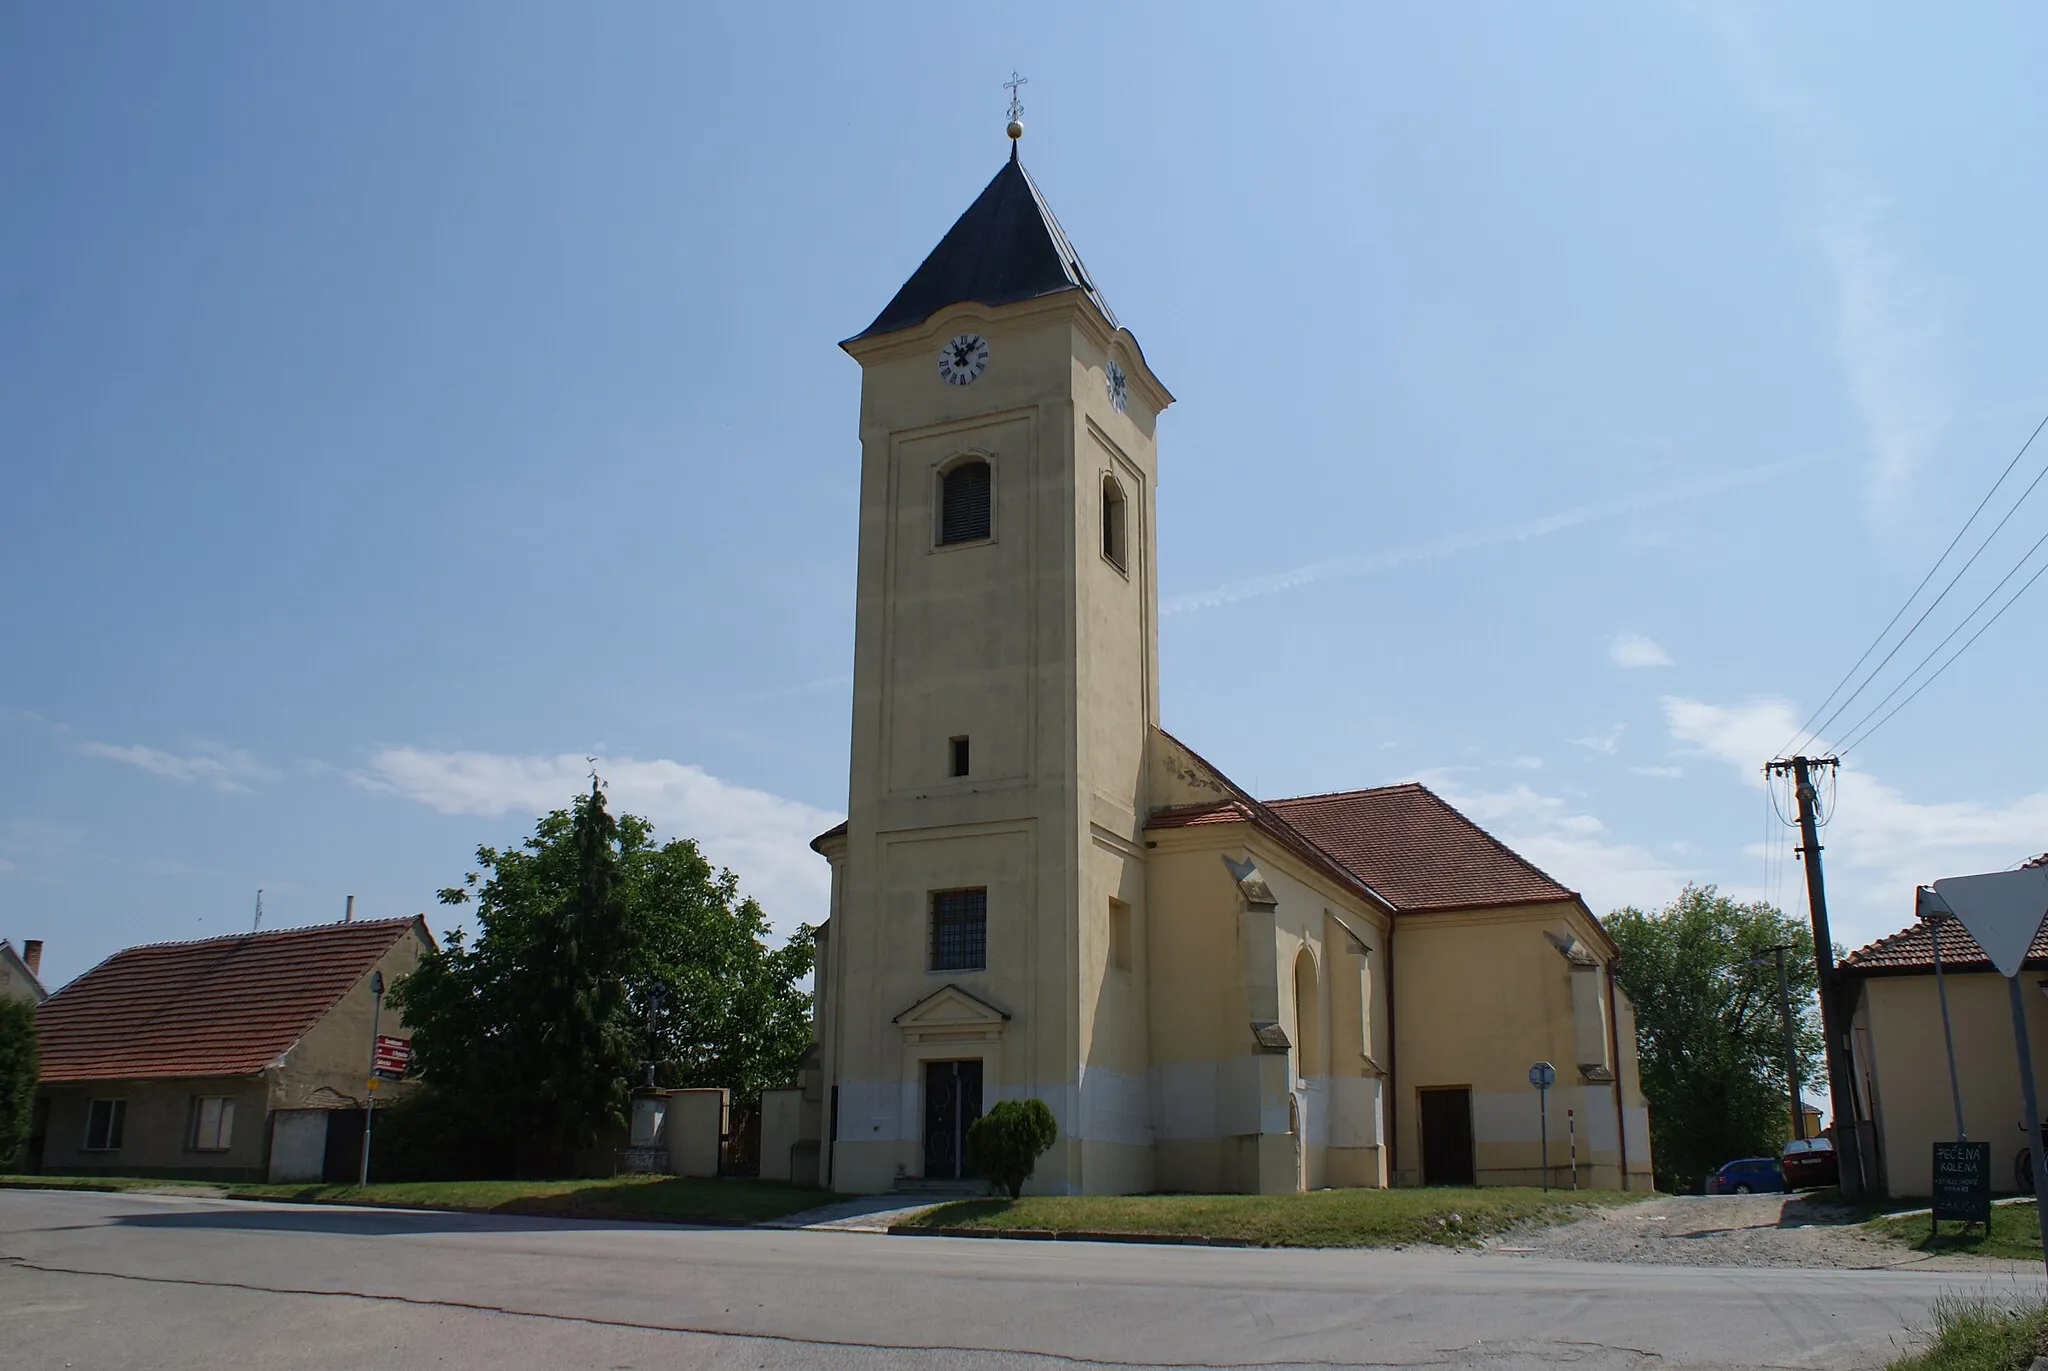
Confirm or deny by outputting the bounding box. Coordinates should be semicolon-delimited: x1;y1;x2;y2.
1604;885;1823;1191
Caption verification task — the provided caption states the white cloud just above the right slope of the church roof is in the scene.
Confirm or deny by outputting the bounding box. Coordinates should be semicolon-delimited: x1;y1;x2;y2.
1421;771;1692;916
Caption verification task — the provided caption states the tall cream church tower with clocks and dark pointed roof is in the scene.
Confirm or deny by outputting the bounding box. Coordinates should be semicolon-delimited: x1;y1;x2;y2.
817;125;1171;1193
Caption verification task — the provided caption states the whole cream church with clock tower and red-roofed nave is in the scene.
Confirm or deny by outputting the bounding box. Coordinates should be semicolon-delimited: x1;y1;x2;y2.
790;123;1651;1195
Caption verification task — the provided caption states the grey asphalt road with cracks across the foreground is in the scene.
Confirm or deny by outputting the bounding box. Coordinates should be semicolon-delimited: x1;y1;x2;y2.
0;1191;2042;1371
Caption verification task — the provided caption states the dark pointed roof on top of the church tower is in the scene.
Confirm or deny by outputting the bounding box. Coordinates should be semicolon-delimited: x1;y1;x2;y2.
848;158;1118;342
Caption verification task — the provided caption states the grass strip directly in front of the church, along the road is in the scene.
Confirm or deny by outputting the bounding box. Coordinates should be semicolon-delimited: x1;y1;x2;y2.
905;1187;1649;1248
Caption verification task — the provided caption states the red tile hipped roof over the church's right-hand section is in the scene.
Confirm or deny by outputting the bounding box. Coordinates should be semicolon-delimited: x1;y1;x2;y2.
1266;783;1577;910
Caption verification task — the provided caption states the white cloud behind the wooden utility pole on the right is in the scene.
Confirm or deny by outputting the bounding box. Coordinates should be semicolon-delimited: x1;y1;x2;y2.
1663;697;2048;947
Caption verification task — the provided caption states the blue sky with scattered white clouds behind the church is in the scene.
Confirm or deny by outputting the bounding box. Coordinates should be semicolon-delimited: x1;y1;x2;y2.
0;4;2048;984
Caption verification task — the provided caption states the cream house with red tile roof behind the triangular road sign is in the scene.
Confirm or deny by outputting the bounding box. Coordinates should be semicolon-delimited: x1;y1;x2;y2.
1837;909;2048;1197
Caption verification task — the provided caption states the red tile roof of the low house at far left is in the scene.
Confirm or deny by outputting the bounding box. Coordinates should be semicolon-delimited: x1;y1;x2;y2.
35;918;430;1082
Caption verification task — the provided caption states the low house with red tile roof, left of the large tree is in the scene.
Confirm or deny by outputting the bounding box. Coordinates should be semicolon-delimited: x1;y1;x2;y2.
29;916;434;1180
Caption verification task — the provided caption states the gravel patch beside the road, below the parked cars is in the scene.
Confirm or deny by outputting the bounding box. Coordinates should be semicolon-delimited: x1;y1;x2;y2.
1485;1195;2034;1271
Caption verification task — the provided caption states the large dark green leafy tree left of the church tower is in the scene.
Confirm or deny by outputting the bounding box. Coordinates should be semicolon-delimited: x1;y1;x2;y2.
393;779;813;1174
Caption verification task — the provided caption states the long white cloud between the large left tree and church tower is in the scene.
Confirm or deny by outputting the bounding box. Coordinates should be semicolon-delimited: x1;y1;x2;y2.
354;748;840;934
